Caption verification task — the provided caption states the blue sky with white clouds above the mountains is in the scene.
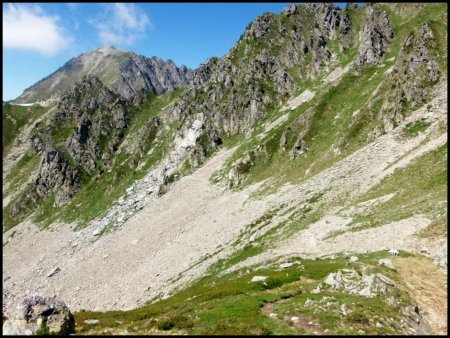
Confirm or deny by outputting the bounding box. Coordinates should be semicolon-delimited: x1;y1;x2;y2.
3;3;350;101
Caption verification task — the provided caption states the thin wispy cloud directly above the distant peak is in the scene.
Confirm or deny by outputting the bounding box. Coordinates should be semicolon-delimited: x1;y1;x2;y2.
91;3;151;45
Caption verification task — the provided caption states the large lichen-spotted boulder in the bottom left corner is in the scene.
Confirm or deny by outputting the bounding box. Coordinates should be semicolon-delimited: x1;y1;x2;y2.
3;295;75;336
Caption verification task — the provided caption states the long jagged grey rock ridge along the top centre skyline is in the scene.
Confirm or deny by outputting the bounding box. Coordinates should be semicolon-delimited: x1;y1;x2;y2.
171;4;352;162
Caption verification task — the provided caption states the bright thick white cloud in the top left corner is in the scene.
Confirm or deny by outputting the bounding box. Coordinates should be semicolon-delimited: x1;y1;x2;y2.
3;4;71;56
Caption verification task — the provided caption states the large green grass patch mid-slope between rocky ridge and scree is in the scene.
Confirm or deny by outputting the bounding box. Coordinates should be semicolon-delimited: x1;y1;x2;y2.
214;61;387;193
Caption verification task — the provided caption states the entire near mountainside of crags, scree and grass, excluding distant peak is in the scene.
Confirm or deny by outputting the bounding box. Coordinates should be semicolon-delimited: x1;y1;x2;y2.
3;3;448;334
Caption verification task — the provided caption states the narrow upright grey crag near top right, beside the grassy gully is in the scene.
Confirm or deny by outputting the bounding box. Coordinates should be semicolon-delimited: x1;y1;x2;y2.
355;6;394;69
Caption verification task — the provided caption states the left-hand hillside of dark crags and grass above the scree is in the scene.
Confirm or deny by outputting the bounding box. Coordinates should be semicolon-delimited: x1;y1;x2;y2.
3;75;183;229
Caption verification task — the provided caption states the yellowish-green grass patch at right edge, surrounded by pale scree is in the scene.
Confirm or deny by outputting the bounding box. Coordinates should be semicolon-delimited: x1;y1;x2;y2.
346;144;447;236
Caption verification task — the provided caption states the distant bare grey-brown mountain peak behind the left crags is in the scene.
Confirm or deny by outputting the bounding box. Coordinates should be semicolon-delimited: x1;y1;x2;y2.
15;46;192;103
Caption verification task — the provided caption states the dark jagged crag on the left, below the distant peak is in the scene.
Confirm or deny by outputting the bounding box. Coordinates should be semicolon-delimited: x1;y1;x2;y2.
10;75;129;218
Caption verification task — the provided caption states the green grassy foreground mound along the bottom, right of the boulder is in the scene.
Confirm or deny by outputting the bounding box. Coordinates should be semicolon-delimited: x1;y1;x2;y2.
75;252;410;335
